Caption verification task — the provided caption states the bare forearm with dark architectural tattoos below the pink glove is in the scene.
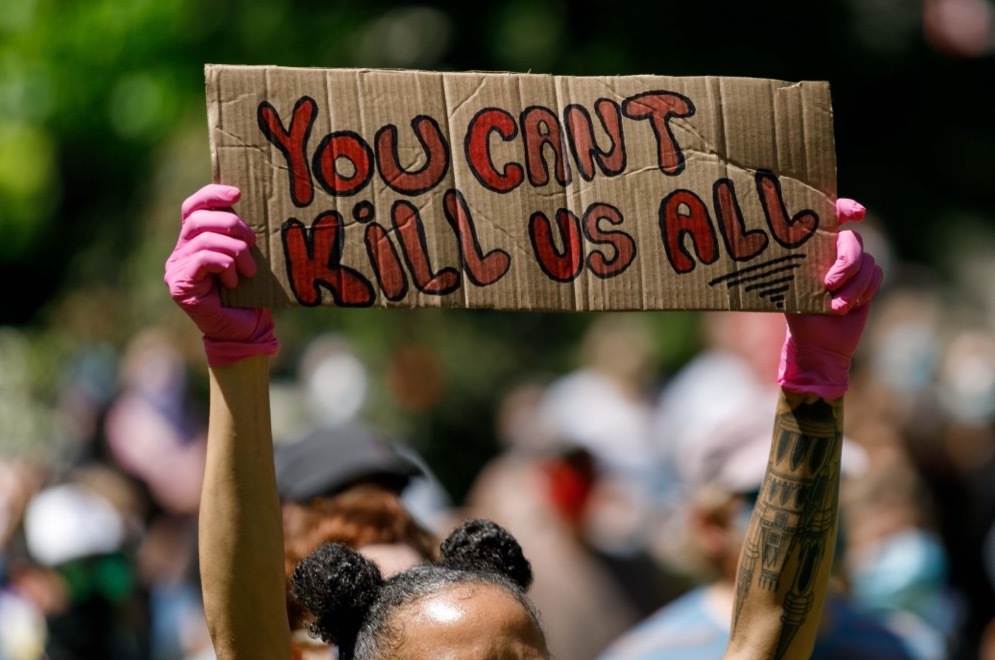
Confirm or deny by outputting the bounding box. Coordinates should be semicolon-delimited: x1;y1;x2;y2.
730;393;843;658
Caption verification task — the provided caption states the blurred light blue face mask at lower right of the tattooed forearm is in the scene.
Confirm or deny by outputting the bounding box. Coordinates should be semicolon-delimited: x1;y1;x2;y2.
850;529;948;620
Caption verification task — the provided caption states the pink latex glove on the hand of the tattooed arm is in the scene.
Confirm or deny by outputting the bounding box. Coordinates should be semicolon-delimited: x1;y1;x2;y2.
777;199;882;401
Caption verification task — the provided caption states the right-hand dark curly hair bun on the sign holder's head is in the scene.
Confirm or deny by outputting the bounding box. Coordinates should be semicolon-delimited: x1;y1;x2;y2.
440;519;532;590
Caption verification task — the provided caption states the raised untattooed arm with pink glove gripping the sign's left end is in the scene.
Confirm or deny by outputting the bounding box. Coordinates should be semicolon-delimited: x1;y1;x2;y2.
165;184;290;660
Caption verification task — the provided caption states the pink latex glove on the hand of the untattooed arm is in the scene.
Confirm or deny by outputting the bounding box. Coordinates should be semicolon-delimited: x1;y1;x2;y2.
164;183;280;367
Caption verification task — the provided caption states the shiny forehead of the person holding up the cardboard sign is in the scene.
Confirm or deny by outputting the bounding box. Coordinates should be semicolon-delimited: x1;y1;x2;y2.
391;584;548;660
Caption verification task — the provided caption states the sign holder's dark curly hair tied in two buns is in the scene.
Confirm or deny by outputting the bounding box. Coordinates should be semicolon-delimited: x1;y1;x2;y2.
291;520;541;660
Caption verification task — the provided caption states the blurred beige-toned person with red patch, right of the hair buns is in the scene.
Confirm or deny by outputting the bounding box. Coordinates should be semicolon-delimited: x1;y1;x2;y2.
464;385;639;660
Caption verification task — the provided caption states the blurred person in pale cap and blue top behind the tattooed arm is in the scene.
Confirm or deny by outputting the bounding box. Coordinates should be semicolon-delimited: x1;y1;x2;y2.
599;378;945;660
